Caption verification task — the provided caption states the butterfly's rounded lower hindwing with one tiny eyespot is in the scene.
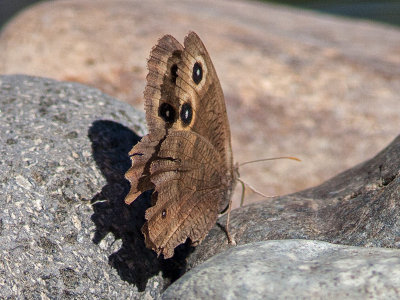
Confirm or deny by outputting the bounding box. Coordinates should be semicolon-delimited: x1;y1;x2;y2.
127;131;227;258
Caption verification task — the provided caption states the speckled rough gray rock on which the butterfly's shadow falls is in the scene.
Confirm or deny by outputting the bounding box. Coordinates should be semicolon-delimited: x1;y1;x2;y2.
0;76;170;299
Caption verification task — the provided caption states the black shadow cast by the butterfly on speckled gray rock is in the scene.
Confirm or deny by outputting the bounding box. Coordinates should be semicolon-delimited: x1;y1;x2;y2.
88;120;191;291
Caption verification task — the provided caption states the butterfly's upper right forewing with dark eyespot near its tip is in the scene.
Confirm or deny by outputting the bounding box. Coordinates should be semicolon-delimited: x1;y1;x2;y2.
176;32;233;178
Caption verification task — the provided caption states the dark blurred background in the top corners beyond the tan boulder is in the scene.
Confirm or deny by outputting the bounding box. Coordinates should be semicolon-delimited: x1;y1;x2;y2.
0;0;400;29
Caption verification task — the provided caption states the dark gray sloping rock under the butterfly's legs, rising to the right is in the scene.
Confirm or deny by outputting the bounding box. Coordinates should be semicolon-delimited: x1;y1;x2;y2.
188;132;400;268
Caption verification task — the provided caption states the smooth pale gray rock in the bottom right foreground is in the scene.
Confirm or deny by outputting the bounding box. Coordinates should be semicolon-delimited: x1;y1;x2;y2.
163;240;400;299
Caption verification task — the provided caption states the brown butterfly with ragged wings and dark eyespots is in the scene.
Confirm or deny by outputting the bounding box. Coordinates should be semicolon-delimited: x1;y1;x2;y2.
125;32;237;258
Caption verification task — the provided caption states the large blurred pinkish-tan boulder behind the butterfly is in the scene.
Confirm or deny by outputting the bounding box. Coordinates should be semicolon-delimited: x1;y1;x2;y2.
0;0;400;205
